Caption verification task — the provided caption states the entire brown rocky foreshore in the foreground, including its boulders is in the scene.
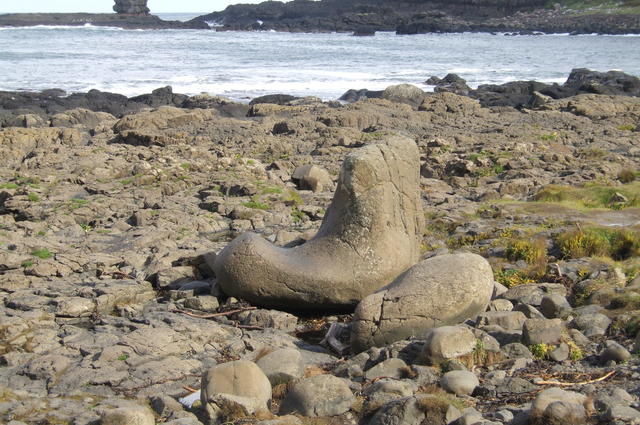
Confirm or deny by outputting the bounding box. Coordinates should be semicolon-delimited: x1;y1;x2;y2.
0;70;640;425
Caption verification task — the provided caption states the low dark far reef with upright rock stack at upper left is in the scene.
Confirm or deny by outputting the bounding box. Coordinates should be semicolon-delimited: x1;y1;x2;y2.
0;0;209;29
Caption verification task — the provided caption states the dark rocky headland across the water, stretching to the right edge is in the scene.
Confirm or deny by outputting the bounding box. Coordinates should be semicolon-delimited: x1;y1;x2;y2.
194;0;640;35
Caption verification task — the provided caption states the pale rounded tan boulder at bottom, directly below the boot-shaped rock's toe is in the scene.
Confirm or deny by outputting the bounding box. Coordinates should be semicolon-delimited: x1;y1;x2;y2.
200;360;271;423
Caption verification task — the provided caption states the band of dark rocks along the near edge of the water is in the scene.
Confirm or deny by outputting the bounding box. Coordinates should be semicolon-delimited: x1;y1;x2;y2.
0;68;640;119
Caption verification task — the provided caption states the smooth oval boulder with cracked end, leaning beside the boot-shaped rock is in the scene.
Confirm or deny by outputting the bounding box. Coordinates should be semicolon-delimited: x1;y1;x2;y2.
351;254;493;353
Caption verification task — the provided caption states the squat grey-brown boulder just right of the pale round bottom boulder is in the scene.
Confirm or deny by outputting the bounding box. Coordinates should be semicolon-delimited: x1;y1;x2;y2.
280;375;355;416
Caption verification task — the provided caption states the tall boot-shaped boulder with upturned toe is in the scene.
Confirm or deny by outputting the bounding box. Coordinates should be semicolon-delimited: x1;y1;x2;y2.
214;136;424;310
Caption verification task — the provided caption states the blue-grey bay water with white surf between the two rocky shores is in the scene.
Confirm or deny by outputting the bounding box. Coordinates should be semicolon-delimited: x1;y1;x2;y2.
0;14;640;101
